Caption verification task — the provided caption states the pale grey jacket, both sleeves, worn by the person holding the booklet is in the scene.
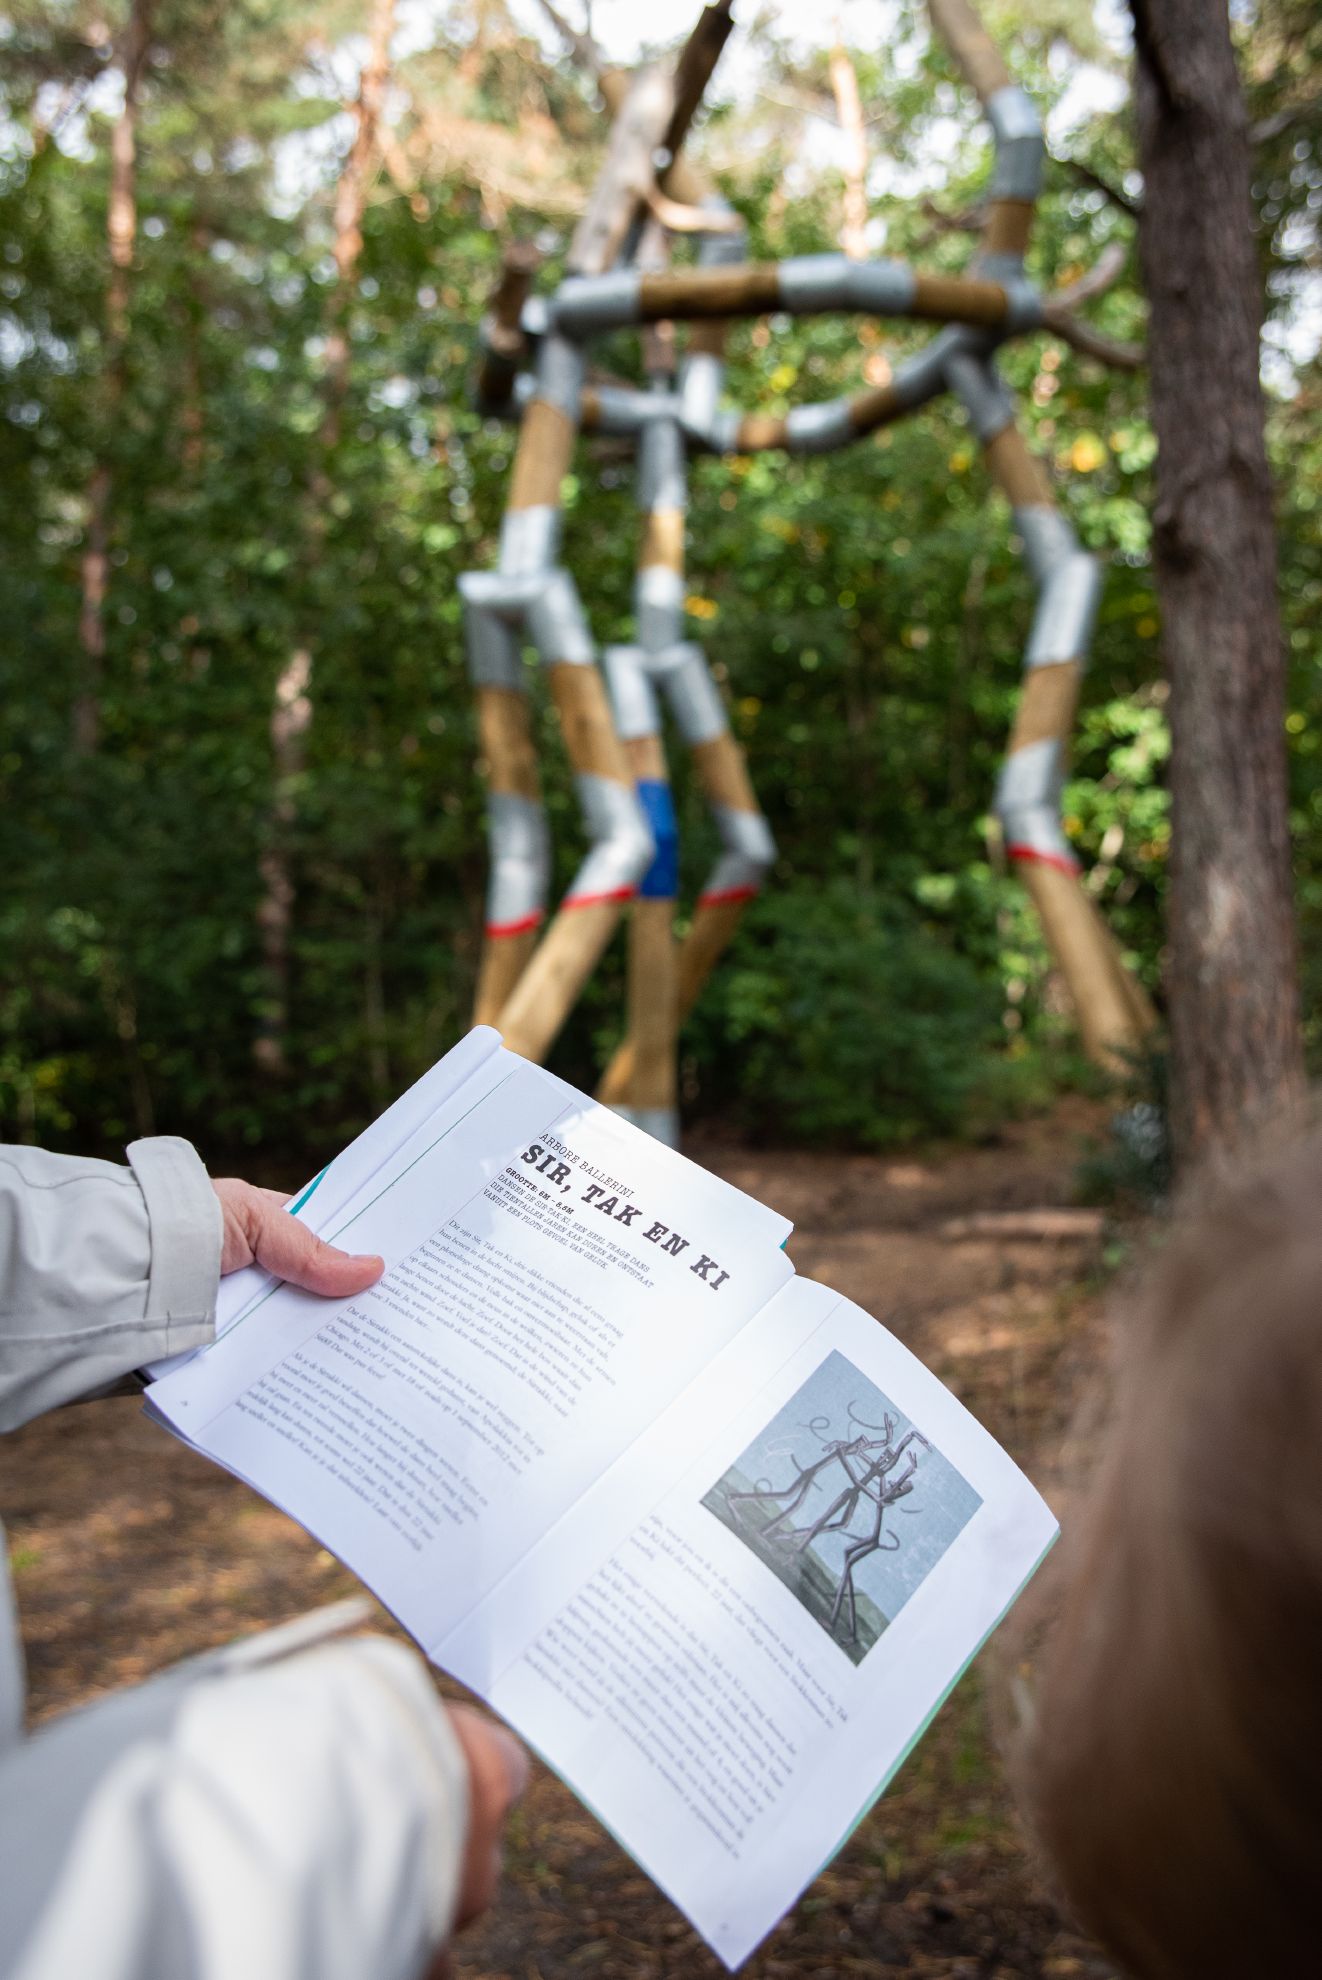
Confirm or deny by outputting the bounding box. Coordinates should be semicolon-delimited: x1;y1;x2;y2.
0;1139;467;1980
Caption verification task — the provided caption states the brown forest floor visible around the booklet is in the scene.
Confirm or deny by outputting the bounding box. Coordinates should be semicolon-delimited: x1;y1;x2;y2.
0;1101;1112;1980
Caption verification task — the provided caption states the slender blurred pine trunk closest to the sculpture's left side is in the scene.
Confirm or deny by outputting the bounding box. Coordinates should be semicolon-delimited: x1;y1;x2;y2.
253;0;396;1075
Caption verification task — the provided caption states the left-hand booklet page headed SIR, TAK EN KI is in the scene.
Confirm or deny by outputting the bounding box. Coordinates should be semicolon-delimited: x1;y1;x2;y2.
150;1051;792;1643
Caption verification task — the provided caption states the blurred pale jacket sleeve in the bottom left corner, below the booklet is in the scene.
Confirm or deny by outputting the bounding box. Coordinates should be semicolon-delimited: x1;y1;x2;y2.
0;1637;467;1980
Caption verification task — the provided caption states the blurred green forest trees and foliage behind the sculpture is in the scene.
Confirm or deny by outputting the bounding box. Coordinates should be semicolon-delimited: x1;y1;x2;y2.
0;0;1322;1166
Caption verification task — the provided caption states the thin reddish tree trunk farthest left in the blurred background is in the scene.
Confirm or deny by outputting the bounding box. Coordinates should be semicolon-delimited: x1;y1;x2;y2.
71;0;154;756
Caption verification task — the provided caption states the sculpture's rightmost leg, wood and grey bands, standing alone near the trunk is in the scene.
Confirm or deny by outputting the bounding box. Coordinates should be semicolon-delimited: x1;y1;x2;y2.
950;356;1154;1067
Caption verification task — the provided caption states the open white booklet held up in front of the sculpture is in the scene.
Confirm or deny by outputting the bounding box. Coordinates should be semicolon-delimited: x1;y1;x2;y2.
150;1030;1057;1966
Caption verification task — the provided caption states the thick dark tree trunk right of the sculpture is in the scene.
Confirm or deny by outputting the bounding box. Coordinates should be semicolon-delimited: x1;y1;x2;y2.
1132;0;1302;1162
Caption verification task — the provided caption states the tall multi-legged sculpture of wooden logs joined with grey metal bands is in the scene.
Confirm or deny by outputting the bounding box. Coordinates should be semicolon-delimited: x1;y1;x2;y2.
461;0;1152;1140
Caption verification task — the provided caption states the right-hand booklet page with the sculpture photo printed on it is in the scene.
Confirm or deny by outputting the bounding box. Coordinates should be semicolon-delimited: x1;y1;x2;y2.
474;1279;1057;1966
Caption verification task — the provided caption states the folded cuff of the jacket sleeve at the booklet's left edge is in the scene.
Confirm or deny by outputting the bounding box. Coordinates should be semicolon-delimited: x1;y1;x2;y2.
129;1135;224;1352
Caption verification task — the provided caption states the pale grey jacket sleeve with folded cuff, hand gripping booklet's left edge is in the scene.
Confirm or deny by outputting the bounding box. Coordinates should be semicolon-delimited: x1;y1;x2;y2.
0;1135;222;1430
